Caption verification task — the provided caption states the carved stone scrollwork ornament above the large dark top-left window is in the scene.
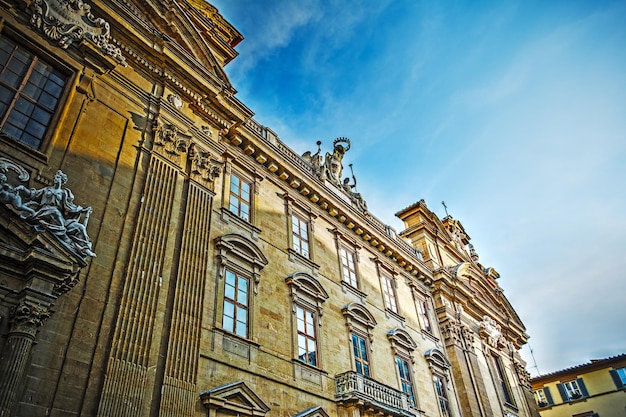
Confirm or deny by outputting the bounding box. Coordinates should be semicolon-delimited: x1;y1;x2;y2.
28;0;126;66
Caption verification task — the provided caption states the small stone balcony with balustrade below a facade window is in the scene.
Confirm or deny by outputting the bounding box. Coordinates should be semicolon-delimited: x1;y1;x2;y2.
335;371;415;417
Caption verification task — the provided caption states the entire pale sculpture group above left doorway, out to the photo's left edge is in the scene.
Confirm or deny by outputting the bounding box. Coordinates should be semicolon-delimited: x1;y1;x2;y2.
0;165;96;258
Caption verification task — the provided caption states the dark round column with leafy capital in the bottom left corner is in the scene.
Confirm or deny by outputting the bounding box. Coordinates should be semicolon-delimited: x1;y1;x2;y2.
0;301;50;417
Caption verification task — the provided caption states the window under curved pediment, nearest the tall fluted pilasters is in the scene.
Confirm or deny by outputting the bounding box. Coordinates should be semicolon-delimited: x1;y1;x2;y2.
222;270;249;338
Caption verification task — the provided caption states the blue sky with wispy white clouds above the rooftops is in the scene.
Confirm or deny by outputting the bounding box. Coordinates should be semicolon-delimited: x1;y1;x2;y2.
211;0;626;376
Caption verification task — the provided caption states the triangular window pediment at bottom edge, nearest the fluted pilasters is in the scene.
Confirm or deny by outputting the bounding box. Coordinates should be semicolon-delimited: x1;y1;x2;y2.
200;381;270;416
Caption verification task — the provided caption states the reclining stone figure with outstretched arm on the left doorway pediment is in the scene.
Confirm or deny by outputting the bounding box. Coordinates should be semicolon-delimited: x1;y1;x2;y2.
15;170;96;257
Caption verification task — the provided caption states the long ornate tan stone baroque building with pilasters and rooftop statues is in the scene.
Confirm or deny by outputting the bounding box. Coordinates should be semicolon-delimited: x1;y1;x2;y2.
0;0;538;417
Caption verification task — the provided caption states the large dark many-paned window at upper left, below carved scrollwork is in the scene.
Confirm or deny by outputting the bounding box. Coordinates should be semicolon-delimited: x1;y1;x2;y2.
0;37;67;149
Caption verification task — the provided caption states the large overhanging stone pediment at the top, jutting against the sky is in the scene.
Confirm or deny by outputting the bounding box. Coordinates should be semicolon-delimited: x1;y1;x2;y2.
123;0;243;87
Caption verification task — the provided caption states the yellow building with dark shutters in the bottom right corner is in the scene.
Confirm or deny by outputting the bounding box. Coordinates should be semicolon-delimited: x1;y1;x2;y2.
531;354;626;417
